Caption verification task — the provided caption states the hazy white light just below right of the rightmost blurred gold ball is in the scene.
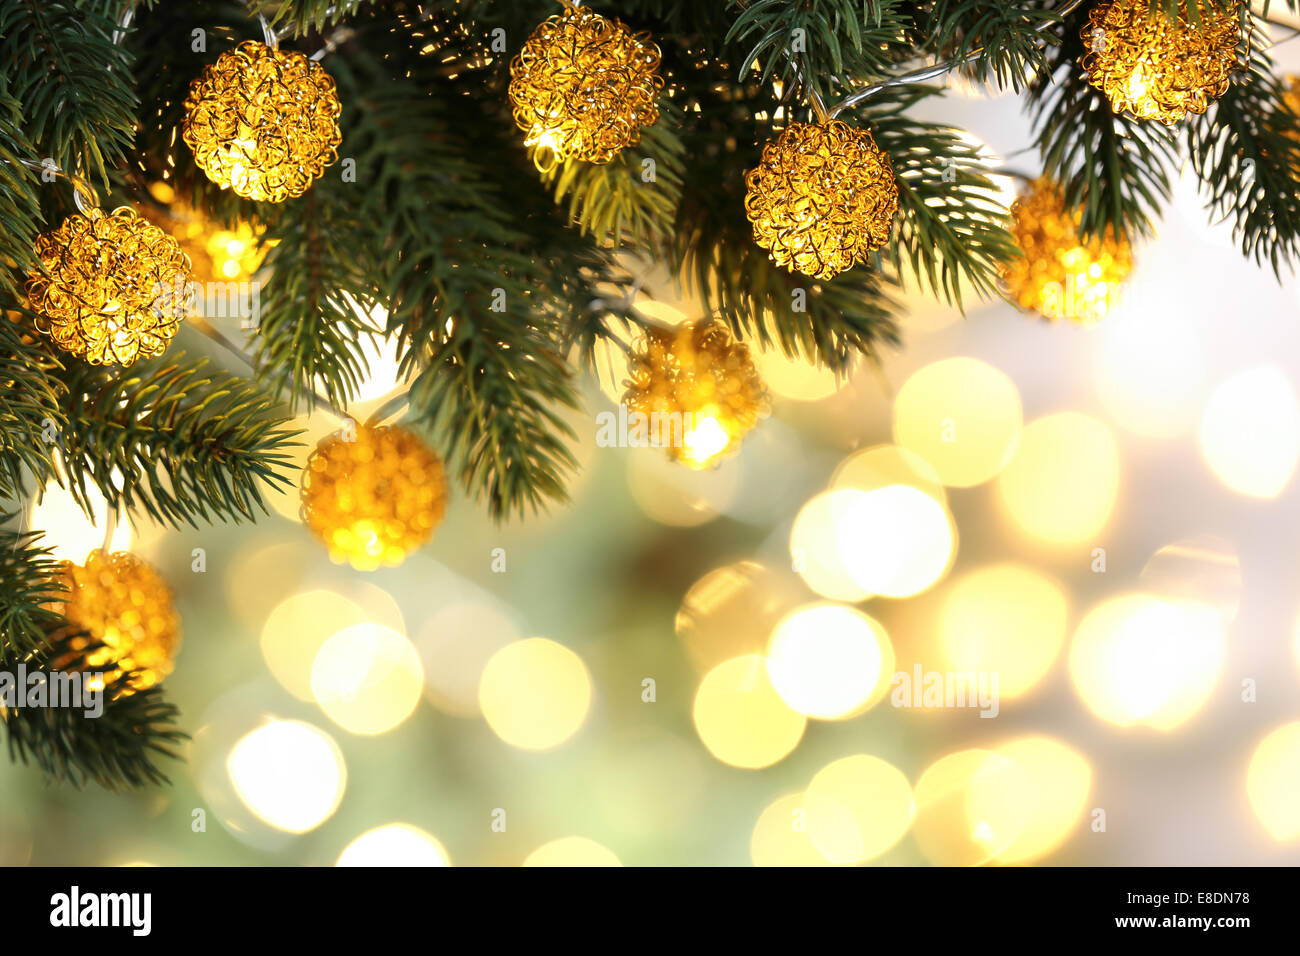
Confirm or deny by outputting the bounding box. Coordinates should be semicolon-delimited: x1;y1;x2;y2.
1095;308;1205;438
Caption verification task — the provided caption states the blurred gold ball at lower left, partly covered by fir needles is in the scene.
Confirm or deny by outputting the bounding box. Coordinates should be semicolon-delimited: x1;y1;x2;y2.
53;550;181;691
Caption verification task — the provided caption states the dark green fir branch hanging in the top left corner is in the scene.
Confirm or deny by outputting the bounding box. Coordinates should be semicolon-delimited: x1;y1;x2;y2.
0;0;138;186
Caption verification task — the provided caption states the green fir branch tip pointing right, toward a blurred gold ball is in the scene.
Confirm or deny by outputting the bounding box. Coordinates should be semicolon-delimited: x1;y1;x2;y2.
64;352;298;527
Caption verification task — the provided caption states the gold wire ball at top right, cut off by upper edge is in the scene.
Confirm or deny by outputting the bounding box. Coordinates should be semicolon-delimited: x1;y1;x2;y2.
1082;0;1242;126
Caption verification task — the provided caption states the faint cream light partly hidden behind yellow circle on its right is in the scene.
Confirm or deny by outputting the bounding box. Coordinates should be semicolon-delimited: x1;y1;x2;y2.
416;604;520;717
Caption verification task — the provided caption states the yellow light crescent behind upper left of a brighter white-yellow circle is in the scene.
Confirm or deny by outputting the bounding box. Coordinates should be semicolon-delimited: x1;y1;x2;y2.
261;589;367;701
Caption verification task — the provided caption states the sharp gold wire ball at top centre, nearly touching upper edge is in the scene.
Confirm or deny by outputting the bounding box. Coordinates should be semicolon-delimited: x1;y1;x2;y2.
510;8;663;170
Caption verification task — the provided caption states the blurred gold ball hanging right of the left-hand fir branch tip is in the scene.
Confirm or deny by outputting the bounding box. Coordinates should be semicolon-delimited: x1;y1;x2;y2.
302;425;447;571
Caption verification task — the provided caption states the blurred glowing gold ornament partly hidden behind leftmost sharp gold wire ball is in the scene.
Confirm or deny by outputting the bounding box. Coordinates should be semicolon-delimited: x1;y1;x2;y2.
142;182;276;282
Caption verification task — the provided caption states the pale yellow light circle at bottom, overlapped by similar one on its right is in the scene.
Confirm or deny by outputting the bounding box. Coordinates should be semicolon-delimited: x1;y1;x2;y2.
913;749;1034;866
